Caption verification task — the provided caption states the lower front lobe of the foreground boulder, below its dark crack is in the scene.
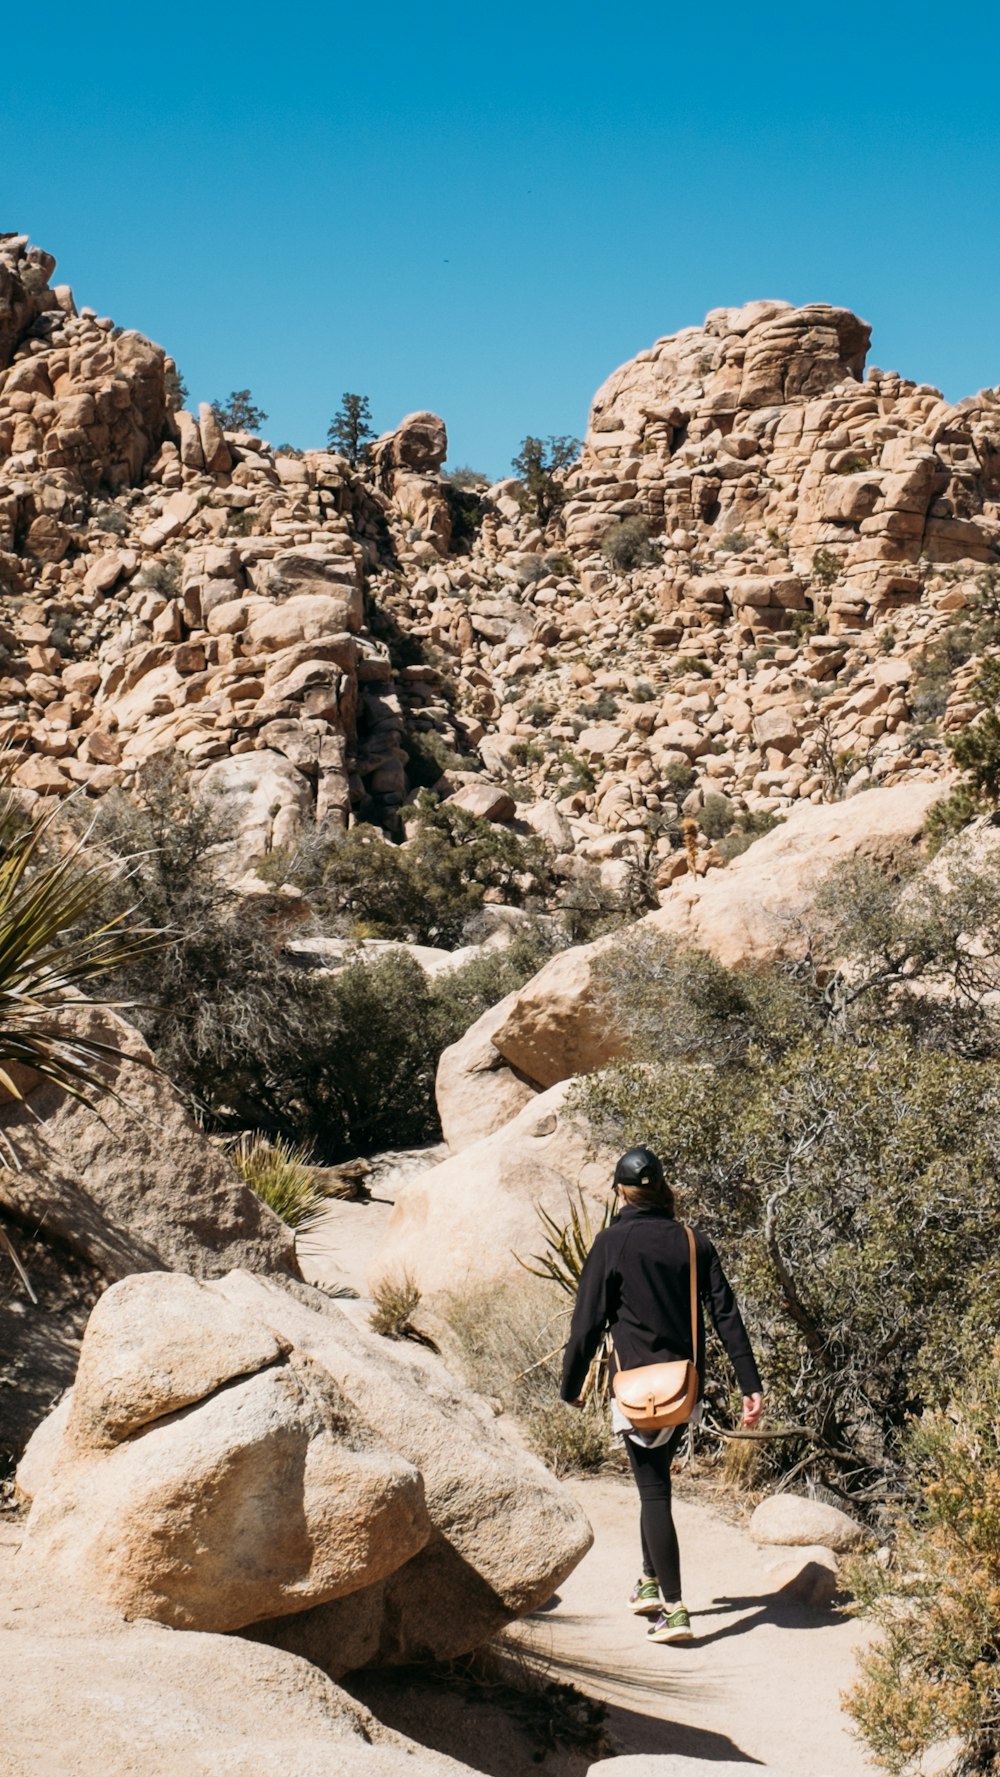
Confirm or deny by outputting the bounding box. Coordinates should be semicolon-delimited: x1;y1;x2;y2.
18;1336;430;1630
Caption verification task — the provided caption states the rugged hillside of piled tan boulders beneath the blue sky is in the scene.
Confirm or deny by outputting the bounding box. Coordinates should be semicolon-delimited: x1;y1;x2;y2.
0;235;1000;889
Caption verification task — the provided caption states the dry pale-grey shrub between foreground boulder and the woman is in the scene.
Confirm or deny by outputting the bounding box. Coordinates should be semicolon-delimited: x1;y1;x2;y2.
444;1285;615;1475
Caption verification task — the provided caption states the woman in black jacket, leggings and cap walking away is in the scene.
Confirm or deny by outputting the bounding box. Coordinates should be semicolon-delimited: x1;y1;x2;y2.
560;1148;762;1642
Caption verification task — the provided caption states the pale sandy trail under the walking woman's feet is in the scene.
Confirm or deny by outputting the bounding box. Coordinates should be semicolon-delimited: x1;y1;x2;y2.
533;1480;874;1777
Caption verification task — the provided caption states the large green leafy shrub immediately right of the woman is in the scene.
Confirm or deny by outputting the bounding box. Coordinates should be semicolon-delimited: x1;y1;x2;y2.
581;885;1000;1510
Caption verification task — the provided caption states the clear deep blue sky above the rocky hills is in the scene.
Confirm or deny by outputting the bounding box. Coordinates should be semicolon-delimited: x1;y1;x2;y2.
0;0;1000;473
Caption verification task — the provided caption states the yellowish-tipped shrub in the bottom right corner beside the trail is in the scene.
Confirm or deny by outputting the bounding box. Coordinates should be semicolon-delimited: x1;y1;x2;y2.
845;1345;1000;1777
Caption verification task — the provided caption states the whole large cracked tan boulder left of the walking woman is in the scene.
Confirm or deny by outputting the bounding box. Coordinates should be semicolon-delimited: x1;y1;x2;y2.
16;1271;590;1676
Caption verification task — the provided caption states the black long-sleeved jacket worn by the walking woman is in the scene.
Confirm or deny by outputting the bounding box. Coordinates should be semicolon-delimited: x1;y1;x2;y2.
560;1205;762;1400
